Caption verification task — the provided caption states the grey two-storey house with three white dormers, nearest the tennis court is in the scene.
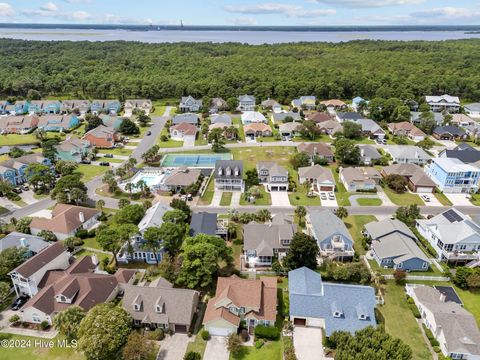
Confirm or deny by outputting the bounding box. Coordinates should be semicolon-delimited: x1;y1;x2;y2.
214;160;245;192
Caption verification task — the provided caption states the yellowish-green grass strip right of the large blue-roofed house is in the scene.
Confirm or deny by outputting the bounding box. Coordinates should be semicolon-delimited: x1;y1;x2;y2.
378;281;431;360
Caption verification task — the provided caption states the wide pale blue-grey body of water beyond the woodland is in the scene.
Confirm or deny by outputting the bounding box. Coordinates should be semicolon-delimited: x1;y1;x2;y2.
0;27;480;45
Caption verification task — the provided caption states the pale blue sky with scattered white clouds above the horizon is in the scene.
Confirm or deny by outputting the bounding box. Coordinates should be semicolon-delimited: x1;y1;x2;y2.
0;0;480;26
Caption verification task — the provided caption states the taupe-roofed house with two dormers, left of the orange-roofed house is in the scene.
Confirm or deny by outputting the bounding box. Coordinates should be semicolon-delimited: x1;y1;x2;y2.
122;278;200;333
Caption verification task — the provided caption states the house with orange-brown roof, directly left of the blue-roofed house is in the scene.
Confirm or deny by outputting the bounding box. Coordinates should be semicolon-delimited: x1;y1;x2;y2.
203;275;277;336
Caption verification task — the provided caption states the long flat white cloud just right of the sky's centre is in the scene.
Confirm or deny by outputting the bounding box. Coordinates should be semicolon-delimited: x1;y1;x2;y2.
223;3;336;18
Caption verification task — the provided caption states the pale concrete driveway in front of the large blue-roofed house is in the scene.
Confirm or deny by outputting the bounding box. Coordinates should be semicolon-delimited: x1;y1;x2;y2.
293;327;325;360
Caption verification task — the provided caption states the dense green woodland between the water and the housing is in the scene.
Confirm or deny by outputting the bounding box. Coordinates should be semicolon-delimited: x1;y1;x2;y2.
0;39;480;102
